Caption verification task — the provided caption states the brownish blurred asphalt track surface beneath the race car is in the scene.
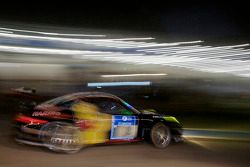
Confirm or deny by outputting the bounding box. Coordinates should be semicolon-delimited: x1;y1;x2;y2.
0;120;250;167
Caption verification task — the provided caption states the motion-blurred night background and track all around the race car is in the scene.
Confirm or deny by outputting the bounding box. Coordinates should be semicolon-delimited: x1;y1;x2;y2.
0;1;250;166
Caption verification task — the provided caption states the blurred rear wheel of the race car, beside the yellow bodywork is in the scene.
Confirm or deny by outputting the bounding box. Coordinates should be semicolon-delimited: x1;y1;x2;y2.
40;122;83;153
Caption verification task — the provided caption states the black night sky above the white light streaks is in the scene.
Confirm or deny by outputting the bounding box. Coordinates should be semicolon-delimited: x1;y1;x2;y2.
0;1;250;38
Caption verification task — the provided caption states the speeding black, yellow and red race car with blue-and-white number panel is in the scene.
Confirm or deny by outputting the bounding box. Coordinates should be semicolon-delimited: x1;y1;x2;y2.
14;92;183;153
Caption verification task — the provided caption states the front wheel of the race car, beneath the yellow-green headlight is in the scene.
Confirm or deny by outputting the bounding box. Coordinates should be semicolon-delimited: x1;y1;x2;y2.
150;122;171;149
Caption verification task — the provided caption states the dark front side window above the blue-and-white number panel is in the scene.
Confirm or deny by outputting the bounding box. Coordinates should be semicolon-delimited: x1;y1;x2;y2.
91;98;133;115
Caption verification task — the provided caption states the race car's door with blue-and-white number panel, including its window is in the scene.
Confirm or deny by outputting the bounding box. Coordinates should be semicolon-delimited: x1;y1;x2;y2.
91;97;139;142
